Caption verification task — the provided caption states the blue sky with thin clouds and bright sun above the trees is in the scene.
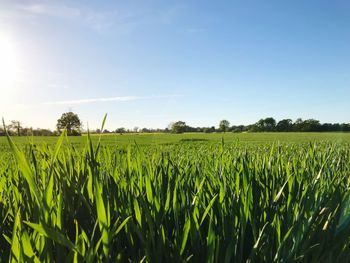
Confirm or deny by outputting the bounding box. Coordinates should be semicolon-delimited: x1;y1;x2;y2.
0;0;350;130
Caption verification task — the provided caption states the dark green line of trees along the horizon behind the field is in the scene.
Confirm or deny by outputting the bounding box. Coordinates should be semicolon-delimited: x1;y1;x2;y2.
0;112;350;136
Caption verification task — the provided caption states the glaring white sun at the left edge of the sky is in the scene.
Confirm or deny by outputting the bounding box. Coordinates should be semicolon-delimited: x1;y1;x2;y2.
0;35;18;92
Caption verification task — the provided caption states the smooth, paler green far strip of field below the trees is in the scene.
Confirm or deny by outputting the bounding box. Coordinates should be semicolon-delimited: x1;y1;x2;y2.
0;132;350;149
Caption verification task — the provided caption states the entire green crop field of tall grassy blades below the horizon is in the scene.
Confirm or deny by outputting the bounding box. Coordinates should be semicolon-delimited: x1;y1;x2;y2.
0;133;350;262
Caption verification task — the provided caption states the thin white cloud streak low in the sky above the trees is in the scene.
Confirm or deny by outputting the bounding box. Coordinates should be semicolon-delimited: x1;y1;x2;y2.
42;94;182;105
